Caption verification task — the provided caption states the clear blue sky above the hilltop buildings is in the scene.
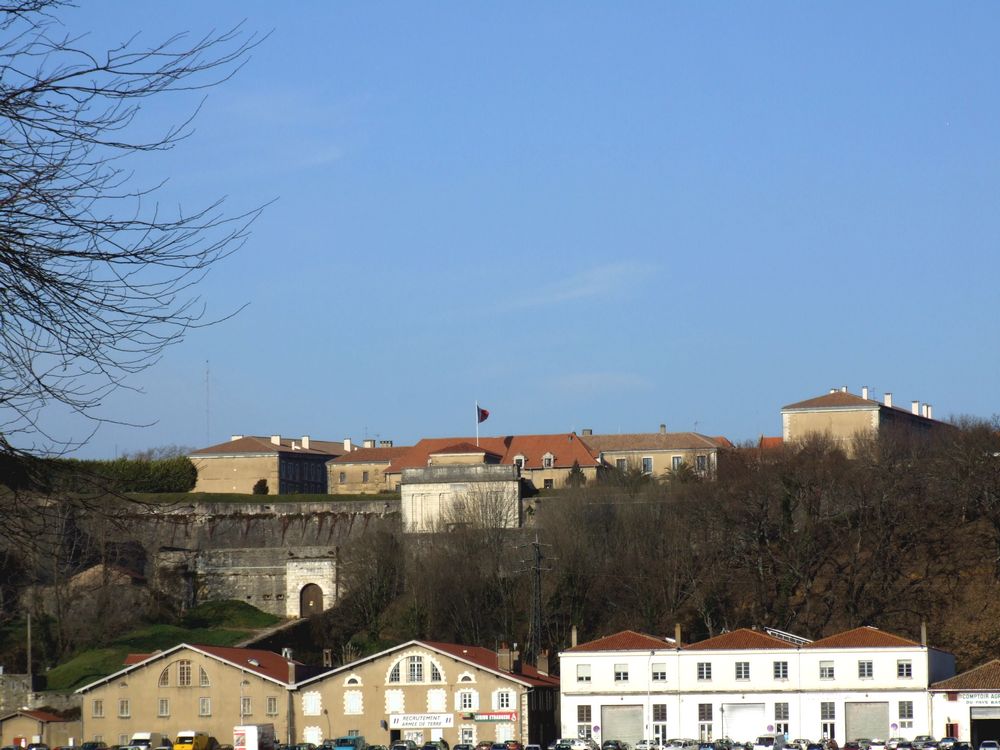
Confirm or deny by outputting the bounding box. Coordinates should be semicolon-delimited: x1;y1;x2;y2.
35;2;1000;456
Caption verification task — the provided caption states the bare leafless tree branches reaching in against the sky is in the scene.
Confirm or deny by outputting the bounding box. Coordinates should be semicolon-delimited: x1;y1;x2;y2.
0;0;259;456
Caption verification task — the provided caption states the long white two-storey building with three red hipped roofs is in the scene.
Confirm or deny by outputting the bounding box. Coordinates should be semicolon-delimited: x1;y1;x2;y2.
560;627;955;744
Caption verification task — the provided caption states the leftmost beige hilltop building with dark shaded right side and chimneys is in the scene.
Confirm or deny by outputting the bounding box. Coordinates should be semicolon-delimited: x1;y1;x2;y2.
188;435;352;495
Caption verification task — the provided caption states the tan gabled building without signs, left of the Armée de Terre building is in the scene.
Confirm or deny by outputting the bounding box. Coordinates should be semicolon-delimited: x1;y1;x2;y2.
76;644;315;745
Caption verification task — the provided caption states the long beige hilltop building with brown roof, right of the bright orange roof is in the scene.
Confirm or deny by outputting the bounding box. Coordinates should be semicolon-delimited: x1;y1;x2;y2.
581;425;733;479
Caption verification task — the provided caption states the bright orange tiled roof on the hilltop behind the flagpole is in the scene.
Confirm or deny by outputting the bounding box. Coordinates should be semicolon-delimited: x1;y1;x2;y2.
386;432;598;474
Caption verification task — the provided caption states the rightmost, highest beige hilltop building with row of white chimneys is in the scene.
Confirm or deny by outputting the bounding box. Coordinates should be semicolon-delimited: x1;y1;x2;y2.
781;386;951;455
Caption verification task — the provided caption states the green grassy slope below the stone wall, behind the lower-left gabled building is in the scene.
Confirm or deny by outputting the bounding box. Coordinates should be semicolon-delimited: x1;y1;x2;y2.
46;601;281;690
